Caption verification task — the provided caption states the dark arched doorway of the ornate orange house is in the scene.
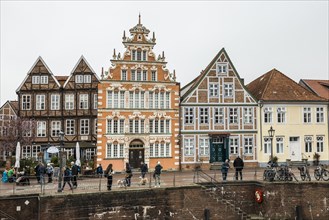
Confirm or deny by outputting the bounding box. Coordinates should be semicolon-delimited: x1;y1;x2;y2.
129;140;144;168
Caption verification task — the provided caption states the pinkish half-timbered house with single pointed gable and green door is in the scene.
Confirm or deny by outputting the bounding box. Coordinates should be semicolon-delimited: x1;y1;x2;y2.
180;48;257;168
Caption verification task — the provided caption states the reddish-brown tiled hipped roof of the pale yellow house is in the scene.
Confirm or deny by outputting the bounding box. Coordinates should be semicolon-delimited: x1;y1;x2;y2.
247;69;325;101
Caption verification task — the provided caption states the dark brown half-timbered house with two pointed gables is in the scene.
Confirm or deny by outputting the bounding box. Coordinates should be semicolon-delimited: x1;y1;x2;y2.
16;56;99;164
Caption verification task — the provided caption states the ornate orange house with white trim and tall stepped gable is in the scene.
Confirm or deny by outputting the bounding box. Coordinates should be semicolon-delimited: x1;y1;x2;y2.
97;17;179;170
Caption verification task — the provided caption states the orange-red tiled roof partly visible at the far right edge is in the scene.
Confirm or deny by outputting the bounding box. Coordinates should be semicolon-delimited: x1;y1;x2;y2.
299;79;329;100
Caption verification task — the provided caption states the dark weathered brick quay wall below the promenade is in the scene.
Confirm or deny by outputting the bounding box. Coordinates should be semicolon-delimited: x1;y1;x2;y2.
0;181;329;220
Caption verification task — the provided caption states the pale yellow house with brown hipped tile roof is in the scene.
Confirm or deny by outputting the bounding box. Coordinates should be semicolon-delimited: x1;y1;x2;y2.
247;69;329;166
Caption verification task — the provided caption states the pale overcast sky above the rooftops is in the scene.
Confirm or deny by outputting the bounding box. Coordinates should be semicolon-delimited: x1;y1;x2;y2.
0;0;329;105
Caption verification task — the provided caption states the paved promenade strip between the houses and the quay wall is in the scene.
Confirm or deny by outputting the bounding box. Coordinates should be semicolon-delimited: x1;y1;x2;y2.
0;167;322;196
